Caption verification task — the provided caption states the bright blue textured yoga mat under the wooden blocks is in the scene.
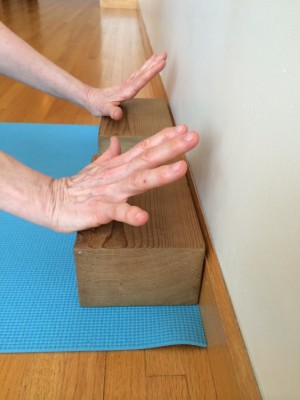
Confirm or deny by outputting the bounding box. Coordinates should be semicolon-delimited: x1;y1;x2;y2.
0;123;206;353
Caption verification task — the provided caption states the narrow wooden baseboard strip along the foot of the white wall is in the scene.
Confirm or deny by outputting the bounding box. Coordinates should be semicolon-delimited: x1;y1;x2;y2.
137;4;261;400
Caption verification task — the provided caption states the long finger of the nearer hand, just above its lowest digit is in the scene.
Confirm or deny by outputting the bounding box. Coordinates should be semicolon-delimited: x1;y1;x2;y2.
120;160;187;198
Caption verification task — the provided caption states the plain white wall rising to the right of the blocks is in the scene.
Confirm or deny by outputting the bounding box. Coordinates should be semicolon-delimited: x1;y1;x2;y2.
139;0;300;400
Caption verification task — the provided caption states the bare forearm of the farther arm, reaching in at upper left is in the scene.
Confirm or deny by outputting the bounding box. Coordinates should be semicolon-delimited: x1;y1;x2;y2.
0;22;89;108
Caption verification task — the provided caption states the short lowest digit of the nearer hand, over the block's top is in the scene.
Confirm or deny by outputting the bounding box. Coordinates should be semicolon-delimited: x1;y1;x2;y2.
106;203;149;226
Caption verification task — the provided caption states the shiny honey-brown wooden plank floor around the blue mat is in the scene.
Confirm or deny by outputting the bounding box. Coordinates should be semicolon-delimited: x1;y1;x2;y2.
0;0;216;400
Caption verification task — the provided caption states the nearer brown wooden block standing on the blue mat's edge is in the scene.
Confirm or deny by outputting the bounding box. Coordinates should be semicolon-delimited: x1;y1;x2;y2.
74;137;204;306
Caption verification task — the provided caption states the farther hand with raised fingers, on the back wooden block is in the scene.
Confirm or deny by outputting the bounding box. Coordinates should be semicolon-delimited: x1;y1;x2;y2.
86;53;167;120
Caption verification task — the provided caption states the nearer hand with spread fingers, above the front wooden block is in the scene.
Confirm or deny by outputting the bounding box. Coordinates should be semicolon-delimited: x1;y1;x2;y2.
46;125;199;232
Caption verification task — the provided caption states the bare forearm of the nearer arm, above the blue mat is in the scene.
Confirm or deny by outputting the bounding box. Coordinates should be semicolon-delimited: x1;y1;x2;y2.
0;151;53;227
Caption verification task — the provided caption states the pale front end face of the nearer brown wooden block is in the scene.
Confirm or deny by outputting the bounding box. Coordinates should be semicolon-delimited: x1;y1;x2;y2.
75;244;203;307
